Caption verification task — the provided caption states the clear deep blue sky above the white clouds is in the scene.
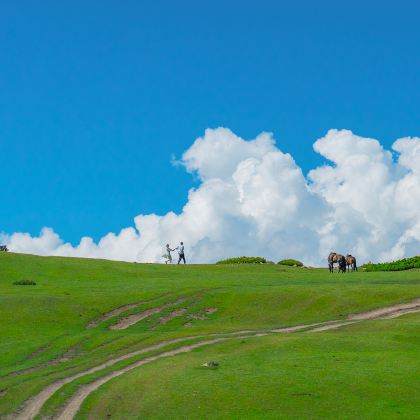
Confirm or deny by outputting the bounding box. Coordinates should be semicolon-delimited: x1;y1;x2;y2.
0;0;420;243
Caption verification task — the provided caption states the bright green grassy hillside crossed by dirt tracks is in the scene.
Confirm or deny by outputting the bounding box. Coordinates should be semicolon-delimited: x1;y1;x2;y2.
0;253;420;419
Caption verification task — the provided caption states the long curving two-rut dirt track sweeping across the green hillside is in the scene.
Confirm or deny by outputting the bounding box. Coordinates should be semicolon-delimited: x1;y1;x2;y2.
11;299;420;420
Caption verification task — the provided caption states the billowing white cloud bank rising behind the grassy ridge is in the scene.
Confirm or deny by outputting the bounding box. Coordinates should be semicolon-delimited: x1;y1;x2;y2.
0;128;420;265
